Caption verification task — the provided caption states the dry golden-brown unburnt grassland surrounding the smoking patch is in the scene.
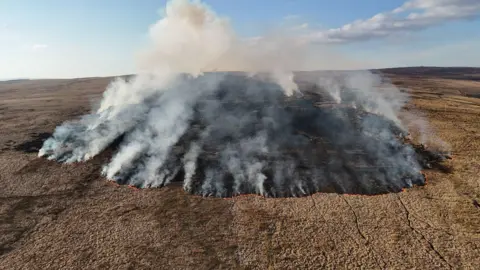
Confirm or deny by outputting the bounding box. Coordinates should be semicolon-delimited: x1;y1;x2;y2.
0;70;480;269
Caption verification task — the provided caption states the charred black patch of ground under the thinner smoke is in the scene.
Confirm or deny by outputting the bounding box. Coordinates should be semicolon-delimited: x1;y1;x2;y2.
108;76;445;197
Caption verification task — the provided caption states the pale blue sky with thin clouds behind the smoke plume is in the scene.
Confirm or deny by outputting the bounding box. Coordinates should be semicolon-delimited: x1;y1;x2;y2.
0;0;480;79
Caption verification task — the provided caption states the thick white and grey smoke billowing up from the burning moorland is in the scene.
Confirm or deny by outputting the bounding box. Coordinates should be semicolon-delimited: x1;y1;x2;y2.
39;0;442;197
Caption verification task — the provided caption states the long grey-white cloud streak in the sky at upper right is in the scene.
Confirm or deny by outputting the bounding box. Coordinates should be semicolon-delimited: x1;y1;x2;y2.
308;0;480;43
